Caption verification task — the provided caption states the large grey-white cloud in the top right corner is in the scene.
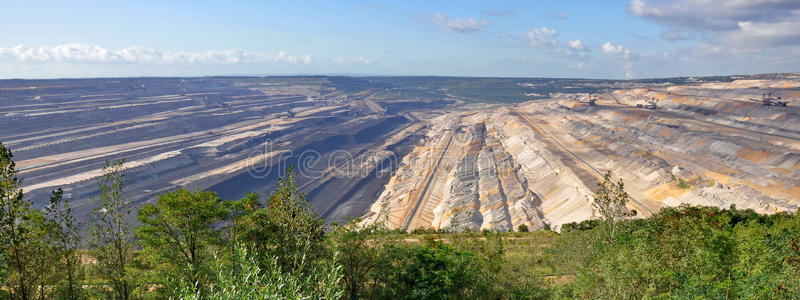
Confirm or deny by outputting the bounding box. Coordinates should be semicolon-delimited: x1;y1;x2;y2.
628;0;800;48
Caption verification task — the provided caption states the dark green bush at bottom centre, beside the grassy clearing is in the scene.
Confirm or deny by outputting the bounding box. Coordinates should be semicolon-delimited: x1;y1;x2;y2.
370;233;503;299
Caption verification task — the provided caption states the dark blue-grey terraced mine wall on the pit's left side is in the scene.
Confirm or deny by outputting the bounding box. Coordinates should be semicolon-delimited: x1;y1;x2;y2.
0;77;447;225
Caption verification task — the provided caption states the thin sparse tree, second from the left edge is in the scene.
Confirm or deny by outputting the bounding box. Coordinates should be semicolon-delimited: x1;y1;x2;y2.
45;188;81;300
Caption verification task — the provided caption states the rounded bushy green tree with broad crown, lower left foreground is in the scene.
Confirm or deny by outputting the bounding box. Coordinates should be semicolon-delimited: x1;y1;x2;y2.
136;189;225;294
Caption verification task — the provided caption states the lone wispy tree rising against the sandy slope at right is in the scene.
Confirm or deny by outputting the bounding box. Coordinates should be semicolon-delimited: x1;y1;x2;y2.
592;171;634;241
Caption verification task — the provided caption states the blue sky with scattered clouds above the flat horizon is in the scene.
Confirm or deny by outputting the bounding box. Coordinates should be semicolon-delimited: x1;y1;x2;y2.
0;0;800;79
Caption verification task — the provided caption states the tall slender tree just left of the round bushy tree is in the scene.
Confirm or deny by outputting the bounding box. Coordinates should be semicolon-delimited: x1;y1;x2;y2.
89;160;135;300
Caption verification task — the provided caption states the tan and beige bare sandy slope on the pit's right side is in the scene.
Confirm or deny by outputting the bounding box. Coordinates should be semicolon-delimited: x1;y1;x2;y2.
364;79;800;230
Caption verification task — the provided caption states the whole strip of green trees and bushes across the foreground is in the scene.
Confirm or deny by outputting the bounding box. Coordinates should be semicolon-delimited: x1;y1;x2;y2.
0;143;800;300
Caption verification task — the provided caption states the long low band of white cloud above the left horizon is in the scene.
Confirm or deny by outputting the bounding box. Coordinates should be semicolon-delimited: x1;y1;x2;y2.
0;43;313;64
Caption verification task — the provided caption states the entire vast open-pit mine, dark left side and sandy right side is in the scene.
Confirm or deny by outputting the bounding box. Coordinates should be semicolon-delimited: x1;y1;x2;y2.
0;73;800;230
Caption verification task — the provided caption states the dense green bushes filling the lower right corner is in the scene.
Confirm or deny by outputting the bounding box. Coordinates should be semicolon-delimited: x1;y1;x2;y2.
550;206;800;299
